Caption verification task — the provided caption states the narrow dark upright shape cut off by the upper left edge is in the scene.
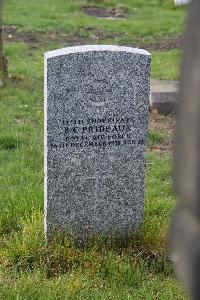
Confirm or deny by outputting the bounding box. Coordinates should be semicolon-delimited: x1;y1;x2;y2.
0;0;8;81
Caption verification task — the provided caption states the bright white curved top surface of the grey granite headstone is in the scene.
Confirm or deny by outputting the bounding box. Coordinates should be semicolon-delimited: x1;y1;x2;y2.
44;45;151;59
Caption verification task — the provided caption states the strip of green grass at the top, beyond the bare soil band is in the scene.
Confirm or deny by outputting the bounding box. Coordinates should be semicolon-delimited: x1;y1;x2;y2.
4;0;185;38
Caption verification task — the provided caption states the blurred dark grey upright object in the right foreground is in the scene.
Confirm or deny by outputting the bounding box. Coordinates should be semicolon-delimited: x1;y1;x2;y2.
170;0;200;300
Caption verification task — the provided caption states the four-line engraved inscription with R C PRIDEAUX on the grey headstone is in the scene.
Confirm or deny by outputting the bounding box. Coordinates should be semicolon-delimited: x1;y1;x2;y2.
50;116;145;150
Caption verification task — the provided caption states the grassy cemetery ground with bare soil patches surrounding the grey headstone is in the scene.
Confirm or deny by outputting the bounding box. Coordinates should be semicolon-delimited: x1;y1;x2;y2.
0;0;188;300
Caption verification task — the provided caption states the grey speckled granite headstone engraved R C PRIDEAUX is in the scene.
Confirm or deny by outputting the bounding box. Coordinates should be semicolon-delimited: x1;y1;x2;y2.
45;46;150;240
